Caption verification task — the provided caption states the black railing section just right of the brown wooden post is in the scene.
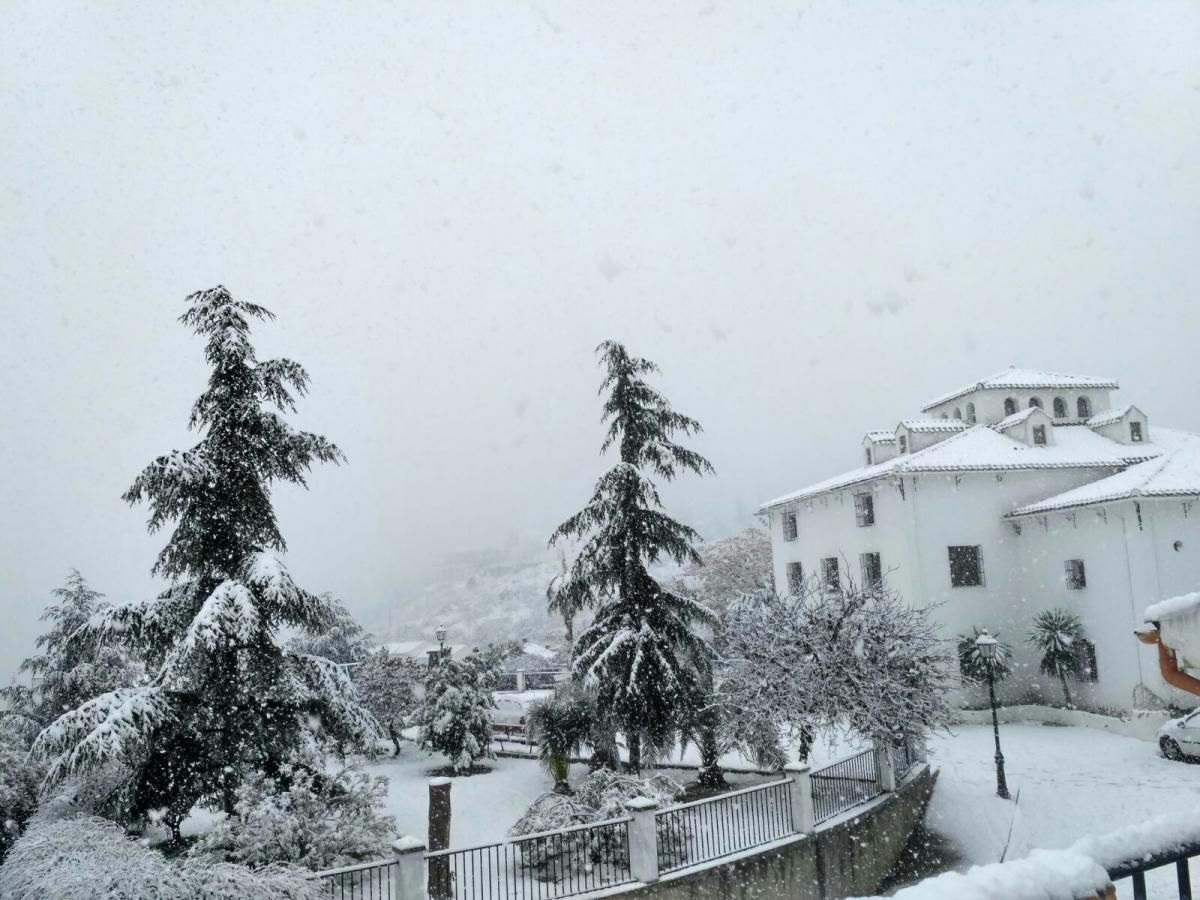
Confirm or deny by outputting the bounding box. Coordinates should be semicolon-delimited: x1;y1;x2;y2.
425;818;634;900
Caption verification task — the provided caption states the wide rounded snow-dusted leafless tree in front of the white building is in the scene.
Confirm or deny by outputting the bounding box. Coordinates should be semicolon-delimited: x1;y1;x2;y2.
716;584;953;756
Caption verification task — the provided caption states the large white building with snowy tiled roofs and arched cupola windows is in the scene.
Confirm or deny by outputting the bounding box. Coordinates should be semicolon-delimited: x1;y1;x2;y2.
761;368;1200;709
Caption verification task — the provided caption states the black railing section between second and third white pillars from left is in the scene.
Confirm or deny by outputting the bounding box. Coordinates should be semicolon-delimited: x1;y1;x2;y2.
654;779;796;874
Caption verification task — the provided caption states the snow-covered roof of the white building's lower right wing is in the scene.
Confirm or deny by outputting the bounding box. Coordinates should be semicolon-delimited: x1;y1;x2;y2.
1008;428;1200;518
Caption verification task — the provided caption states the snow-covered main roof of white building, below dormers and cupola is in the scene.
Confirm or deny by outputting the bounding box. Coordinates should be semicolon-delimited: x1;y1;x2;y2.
760;425;1171;512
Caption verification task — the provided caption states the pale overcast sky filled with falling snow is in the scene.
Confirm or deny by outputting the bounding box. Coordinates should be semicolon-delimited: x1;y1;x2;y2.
0;0;1200;678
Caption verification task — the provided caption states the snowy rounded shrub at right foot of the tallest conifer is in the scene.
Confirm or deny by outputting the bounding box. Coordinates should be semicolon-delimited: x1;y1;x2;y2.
191;766;396;871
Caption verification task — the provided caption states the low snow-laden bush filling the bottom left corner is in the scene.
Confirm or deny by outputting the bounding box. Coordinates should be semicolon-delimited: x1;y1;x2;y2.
0;815;328;900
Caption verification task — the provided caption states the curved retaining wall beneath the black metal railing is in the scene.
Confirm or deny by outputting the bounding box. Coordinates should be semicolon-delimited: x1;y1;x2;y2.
612;769;937;900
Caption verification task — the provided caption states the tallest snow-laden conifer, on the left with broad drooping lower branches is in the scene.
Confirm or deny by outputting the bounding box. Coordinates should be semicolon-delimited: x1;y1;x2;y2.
34;287;379;841
